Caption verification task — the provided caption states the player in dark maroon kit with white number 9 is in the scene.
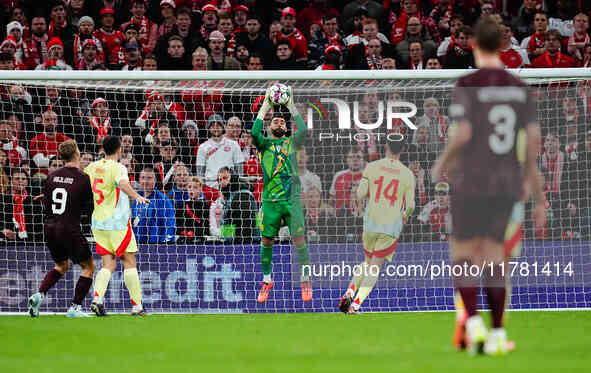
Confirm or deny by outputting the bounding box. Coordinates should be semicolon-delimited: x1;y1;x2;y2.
29;140;95;317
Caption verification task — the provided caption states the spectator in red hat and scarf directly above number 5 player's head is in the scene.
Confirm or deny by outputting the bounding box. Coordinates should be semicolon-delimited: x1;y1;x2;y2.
86;97;121;153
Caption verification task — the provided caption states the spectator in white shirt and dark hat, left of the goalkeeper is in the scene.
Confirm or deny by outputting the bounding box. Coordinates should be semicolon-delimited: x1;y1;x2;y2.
197;114;244;188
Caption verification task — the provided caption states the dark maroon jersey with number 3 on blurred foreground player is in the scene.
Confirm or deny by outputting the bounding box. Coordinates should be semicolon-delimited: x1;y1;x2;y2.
449;69;536;199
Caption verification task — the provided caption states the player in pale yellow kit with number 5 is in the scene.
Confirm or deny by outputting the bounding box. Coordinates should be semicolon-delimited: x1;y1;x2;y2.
84;136;150;316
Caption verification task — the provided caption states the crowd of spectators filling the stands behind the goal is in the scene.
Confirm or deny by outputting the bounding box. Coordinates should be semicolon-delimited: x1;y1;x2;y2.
0;0;591;243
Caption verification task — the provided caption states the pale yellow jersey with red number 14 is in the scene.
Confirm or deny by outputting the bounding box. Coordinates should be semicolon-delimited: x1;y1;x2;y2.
358;158;415;238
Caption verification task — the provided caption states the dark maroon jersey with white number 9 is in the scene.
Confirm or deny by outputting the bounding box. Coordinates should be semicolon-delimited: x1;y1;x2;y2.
43;167;92;231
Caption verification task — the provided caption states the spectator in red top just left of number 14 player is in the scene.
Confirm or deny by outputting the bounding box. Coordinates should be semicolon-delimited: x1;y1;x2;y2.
328;147;365;210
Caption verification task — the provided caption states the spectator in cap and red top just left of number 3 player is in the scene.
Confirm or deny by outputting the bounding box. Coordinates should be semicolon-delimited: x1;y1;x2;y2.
417;182;452;241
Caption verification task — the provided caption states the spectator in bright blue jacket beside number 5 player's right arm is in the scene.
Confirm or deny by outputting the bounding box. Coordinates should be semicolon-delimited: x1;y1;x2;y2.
131;167;176;243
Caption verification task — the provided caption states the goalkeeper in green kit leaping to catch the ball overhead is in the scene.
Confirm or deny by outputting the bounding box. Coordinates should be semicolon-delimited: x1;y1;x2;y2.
252;88;312;303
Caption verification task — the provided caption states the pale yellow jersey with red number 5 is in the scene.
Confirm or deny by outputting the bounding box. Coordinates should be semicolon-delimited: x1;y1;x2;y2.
84;159;131;230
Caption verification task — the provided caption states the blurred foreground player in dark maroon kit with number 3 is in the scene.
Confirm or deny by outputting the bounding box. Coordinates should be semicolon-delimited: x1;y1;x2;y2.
432;17;545;355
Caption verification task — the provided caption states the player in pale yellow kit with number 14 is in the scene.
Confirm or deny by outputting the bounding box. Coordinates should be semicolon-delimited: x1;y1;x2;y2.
339;135;416;313
